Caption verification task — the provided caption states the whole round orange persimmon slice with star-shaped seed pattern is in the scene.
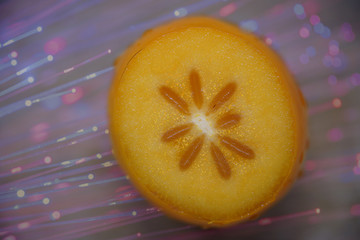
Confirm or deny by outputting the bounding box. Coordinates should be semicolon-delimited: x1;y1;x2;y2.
109;17;307;226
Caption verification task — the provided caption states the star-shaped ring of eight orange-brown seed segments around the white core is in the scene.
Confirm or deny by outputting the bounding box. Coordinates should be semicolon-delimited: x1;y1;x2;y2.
159;69;255;179
